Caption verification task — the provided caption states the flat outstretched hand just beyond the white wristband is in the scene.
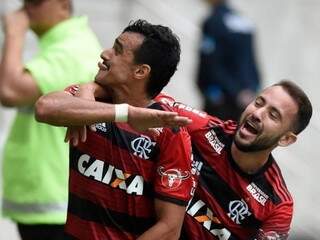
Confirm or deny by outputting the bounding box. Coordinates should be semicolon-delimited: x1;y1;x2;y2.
128;105;192;131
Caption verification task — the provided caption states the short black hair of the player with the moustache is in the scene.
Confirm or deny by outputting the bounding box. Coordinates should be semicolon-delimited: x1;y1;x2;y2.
123;19;181;98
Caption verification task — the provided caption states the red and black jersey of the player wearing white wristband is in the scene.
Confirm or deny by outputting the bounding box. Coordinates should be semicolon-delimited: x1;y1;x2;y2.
65;100;195;240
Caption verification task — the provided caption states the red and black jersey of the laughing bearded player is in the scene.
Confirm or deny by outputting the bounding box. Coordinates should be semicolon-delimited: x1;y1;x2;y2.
156;95;293;240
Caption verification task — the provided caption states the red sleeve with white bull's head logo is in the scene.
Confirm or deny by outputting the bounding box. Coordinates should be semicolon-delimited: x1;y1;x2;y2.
154;125;195;205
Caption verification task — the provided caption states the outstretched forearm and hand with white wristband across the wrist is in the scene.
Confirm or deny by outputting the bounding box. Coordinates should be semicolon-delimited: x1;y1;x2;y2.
36;91;190;130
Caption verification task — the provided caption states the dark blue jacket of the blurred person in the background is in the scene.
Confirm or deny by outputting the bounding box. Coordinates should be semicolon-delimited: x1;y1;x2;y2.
197;4;260;99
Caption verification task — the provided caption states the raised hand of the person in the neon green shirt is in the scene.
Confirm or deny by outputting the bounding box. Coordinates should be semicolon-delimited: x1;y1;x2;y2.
3;9;30;36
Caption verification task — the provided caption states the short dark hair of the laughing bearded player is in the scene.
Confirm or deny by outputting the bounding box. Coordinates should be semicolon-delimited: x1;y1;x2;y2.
273;80;312;134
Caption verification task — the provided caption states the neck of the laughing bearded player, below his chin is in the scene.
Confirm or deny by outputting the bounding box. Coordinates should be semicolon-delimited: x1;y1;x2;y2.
231;143;270;174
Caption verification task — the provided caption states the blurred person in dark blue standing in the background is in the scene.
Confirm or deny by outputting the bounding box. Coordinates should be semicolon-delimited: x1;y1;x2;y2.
196;0;260;120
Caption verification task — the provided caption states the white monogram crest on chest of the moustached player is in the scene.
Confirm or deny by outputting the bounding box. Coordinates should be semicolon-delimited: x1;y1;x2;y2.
131;136;156;159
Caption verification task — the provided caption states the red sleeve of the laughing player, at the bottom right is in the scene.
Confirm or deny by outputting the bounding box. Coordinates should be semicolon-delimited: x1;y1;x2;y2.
256;202;293;240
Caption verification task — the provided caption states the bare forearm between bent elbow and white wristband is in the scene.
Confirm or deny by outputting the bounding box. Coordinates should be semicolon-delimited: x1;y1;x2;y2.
36;92;115;126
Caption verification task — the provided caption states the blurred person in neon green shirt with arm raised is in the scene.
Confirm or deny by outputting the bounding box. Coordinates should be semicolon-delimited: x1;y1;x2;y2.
0;0;101;240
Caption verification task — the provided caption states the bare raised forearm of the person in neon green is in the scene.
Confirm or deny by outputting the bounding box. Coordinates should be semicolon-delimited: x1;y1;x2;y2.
0;33;24;105
